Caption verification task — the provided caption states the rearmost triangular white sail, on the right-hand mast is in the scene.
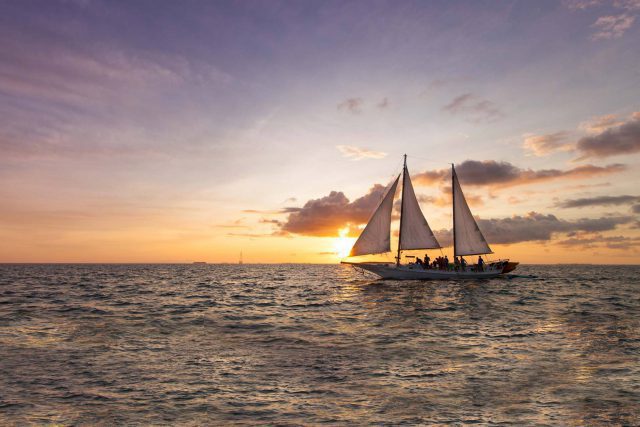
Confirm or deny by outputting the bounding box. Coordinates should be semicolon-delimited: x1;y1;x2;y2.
451;168;493;256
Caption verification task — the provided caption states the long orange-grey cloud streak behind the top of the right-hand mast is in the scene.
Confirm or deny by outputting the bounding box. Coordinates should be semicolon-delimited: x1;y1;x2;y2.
413;160;625;187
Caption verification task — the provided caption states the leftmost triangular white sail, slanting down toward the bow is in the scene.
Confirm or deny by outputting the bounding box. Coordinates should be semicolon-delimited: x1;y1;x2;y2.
349;175;400;256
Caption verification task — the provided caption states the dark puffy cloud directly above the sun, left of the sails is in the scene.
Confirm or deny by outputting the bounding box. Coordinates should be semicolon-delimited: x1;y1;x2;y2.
280;184;385;237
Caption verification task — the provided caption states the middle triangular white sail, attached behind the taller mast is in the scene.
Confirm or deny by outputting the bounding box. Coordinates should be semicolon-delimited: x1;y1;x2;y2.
400;169;440;250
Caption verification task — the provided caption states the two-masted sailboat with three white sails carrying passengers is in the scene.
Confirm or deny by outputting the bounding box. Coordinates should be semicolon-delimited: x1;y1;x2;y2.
342;154;518;280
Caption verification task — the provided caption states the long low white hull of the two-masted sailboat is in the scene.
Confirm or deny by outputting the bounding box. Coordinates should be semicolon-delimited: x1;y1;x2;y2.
345;262;506;280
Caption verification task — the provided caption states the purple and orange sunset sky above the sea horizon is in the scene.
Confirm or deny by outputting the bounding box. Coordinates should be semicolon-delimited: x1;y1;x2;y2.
0;0;640;263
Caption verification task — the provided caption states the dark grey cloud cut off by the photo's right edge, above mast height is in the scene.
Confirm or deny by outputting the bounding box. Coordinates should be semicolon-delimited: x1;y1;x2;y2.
576;113;640;160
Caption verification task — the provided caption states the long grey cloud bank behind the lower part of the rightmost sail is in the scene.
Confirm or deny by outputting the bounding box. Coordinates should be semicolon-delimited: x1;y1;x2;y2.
435;212;634;246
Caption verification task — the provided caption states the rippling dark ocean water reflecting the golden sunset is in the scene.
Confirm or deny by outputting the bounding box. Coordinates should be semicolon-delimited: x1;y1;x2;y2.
0;265;640;425
